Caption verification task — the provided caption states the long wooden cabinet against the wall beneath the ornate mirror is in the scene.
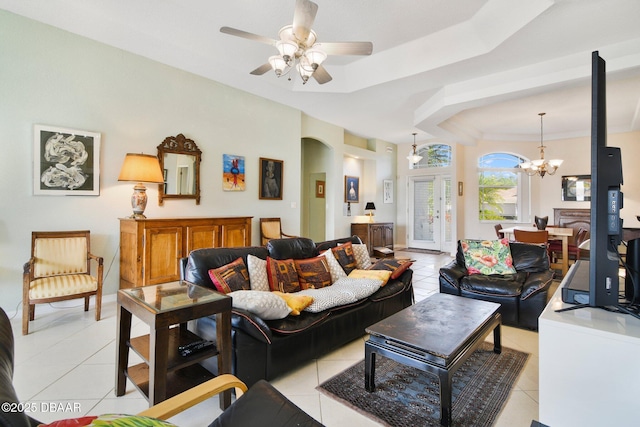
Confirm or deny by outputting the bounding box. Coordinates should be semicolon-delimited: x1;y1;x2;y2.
120;217;252;289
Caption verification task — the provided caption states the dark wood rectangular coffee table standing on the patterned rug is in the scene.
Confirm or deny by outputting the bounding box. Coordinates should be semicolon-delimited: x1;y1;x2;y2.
364;294;502;426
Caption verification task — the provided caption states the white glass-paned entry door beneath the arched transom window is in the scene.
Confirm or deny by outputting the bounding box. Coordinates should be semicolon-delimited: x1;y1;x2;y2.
407;175;453;252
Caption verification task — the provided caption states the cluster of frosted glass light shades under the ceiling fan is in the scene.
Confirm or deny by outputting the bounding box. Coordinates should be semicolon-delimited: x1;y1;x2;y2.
269;25;327;84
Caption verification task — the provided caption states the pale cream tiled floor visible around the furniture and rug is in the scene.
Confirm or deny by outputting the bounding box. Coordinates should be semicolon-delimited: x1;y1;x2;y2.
12;251;538;427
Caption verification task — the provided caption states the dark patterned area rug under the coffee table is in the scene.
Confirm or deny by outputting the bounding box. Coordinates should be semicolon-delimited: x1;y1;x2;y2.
318;343;529;427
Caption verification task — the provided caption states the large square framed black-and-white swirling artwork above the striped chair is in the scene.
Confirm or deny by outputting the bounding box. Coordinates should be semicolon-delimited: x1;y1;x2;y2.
33;125;100;196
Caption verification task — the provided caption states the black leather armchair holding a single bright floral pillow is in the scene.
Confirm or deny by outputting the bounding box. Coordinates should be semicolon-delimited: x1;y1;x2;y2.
439;241;554;330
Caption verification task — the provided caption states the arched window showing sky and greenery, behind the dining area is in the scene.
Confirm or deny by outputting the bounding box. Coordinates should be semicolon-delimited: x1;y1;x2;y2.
478;153;531;222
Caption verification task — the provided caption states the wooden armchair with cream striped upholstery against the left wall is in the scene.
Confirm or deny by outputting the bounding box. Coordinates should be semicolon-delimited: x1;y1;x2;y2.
22;230;103;335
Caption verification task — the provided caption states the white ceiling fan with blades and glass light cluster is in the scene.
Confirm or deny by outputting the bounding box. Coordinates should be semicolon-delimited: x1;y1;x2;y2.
220;0;373;84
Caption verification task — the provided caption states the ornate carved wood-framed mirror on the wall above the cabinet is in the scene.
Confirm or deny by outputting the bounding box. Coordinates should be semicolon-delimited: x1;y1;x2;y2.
158;134;202;206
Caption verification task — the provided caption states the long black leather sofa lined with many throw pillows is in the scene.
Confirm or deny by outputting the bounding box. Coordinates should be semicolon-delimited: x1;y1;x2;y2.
183;236;413;386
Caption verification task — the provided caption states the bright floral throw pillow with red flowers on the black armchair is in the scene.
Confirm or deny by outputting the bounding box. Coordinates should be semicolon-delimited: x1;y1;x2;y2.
460;239;516;274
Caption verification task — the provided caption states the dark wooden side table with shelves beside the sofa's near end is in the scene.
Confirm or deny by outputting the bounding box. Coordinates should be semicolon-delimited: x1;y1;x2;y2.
115;281;231;410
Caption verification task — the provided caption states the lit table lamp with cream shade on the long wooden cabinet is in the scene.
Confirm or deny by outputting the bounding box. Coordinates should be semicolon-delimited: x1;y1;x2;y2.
118;153;164;218
